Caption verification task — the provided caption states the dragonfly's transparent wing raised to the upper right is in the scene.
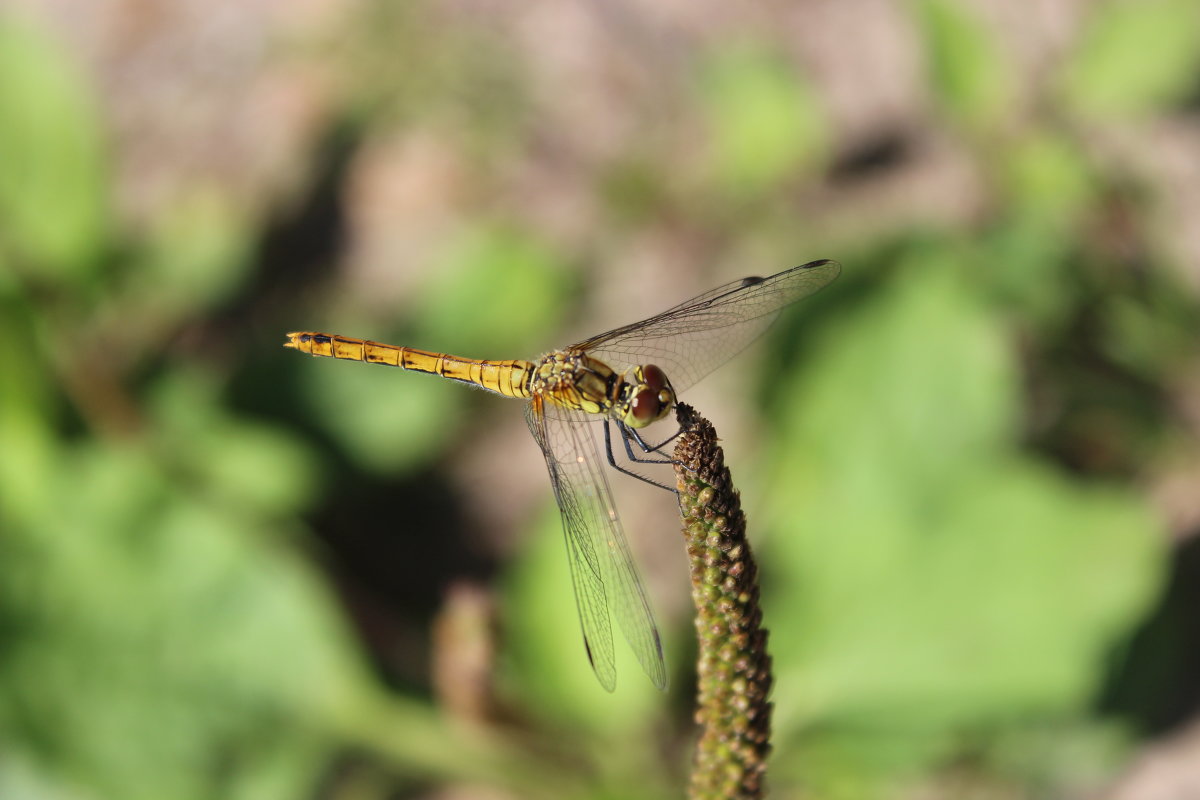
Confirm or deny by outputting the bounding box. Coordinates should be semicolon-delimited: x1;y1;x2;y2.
566;260;841;392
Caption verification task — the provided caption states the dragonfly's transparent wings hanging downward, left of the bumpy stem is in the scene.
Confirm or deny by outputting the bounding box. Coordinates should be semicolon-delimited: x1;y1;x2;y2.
526;396;667;692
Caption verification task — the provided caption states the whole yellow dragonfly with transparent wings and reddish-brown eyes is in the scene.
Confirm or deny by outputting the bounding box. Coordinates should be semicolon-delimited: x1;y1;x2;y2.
283;260;841;692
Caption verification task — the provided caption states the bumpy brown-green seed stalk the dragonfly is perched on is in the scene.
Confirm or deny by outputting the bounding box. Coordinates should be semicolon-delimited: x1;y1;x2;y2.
674;405;772;800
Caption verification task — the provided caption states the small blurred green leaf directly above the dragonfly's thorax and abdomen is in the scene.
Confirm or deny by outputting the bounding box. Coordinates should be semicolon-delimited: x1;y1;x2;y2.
416;224;566;359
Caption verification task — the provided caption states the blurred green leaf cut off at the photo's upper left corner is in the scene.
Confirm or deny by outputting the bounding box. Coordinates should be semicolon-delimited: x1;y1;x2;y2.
0;13;108;279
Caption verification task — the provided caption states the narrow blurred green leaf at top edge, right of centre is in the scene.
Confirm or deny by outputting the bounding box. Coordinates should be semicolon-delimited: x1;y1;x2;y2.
916;0;1015;132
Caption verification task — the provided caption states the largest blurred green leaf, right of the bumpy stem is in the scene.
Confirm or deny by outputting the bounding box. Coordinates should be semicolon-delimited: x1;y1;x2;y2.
763;253;1162;786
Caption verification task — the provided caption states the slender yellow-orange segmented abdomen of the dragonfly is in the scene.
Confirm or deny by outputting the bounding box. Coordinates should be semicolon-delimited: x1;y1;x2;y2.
283;331;534;397
